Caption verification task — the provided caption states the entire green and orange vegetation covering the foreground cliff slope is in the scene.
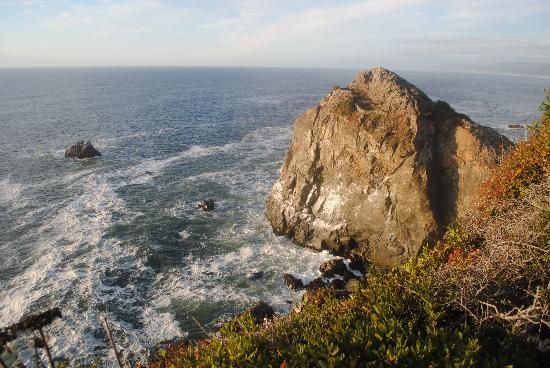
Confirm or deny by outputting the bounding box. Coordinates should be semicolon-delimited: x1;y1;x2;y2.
144;95;550;367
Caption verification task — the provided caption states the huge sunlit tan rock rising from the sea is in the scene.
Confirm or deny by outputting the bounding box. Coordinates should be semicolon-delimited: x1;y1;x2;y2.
266;68;511;265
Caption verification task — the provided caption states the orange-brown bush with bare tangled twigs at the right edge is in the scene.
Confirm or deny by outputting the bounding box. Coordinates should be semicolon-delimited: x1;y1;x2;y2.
436;91;550;356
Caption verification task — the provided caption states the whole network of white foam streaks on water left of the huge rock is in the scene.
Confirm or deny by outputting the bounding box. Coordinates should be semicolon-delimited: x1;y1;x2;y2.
0;122;302;364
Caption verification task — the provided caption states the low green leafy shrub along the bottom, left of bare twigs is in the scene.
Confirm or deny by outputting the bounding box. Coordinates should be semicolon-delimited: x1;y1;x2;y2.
146;246;548;367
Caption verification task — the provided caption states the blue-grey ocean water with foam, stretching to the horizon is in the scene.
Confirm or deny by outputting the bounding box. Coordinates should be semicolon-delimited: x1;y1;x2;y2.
0;68;550;365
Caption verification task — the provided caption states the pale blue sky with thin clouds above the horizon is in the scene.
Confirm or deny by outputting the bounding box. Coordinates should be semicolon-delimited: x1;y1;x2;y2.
0;0;550;70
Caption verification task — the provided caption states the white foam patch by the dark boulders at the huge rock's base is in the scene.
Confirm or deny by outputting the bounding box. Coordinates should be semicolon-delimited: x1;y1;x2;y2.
151;236;334;320
